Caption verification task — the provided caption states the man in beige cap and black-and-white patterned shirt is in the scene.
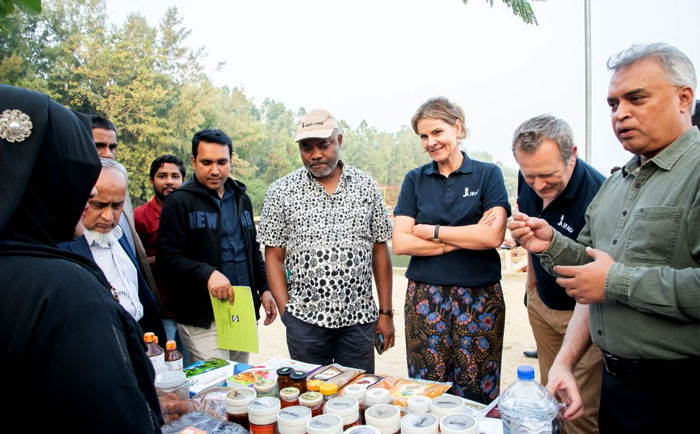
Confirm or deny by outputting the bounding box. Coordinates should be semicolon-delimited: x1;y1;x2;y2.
258;110;394;373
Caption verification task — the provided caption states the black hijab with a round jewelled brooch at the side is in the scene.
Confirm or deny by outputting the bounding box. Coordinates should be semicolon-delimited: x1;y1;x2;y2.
0;84;101;251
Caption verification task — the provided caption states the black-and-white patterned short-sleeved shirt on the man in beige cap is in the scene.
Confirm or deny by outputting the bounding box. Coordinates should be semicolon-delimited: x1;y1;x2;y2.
258;162;391;328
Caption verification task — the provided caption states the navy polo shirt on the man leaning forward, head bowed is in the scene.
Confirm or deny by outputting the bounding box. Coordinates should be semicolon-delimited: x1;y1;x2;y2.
518;159;605;310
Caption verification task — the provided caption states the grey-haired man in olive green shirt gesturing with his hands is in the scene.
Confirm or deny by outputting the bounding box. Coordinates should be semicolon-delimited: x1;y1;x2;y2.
509;43;700;433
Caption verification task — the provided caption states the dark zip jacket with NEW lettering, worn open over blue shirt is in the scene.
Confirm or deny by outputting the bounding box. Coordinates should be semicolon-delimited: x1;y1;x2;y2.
156;177;268;328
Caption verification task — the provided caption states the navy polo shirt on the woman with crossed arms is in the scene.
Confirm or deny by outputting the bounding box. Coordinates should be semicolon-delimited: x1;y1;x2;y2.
394;152;510;287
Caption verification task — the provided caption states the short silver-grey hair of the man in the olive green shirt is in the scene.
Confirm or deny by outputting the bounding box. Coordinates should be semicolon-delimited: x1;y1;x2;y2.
608;42;698;114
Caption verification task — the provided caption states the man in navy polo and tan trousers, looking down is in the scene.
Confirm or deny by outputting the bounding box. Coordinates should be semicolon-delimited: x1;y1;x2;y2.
513;115;605;434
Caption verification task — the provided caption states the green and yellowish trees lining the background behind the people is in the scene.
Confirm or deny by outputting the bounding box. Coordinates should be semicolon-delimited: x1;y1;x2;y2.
0;0;517;214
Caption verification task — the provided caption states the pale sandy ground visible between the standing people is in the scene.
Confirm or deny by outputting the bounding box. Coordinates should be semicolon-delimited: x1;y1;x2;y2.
250;269;539;390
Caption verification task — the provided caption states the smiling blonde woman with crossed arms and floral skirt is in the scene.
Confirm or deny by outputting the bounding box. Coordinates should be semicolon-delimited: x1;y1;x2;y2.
392;98;510;403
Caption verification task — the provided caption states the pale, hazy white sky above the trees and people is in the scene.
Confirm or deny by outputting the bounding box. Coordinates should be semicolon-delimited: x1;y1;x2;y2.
107;0;700;174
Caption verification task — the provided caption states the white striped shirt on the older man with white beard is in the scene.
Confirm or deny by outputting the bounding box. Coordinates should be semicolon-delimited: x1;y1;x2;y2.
85;226;143;321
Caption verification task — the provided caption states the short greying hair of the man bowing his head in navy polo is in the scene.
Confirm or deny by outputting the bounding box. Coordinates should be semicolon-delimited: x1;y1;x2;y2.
512;114;576;163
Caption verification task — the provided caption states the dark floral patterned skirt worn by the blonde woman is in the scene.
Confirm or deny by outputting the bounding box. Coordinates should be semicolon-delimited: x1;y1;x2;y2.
404;280;506;403
